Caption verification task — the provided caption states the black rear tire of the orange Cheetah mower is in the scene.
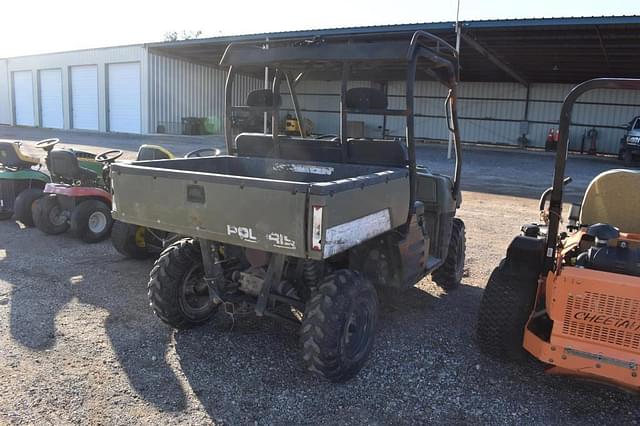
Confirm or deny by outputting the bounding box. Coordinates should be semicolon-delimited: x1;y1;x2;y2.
476;260;538;361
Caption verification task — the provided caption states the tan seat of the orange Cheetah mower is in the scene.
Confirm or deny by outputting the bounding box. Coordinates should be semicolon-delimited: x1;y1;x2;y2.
580;169;640;233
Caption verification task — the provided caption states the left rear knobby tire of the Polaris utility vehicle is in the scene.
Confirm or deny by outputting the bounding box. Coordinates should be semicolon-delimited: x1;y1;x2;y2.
147;238;218;330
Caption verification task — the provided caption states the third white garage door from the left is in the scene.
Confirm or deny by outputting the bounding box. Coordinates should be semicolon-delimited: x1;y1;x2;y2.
71;65;98;130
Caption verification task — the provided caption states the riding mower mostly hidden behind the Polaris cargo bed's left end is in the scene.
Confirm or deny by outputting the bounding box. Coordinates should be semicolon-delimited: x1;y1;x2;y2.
111;145;220;259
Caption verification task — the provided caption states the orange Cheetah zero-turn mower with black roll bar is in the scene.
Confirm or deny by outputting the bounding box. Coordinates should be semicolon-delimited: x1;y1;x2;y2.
477;79;640;391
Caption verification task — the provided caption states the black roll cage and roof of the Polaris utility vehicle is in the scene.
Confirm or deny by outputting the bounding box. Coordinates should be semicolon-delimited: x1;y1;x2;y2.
220;31;462;212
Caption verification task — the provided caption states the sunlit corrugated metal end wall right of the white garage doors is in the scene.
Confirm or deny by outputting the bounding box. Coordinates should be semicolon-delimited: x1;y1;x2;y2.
149;53;264;134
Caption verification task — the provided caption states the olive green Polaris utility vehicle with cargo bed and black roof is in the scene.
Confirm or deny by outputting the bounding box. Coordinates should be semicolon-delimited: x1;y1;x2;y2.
111;31;465;381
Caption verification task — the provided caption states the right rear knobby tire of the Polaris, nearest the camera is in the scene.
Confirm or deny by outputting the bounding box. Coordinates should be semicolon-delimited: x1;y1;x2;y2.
300;269;378;382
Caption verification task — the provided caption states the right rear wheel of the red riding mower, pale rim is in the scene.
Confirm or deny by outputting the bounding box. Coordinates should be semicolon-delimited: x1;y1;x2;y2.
71;200;113;243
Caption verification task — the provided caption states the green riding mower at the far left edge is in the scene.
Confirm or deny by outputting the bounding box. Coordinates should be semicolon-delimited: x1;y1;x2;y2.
0;139;49;226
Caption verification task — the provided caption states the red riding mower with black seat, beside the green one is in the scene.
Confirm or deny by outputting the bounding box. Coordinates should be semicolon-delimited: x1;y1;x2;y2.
33;140;123;243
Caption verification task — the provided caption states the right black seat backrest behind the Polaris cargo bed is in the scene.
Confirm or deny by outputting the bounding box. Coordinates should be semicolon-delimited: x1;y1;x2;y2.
347;139;409;167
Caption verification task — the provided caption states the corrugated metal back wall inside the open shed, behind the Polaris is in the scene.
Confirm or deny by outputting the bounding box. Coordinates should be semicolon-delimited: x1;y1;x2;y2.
276;81;640;154
